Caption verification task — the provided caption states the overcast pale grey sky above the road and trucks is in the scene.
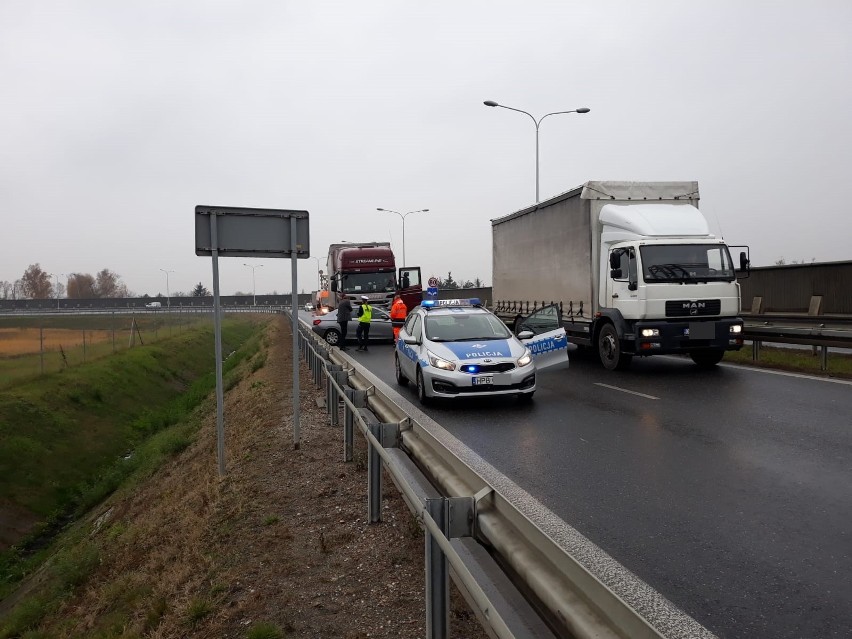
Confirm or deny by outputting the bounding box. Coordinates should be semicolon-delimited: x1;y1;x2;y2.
0;0;852;295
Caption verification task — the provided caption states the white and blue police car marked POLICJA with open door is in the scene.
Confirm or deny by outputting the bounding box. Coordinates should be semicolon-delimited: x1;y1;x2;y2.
394;299;568;404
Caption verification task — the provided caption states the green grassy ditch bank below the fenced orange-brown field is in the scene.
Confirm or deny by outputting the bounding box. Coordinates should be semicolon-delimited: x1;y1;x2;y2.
0;318;268;637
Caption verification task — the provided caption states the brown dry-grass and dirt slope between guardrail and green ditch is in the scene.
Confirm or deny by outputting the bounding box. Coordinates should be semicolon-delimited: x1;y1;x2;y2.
0;319;486;639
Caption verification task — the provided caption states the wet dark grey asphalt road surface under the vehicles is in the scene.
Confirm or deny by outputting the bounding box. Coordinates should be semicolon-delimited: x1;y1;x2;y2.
330;328;852;639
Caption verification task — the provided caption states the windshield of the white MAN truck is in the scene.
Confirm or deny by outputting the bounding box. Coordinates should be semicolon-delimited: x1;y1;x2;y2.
639;244;736;282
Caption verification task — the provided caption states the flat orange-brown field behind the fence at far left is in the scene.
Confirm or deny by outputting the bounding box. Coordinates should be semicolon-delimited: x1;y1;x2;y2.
0;313;206;388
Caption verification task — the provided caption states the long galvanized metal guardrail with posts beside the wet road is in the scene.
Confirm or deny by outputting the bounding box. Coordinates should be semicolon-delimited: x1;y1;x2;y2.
290;316;713;639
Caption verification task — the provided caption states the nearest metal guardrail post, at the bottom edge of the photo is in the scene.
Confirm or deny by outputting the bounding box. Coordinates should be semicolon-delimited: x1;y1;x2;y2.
426;497;450;639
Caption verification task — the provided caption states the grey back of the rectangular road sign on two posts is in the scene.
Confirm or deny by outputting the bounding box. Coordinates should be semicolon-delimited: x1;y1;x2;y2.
195;205;311;259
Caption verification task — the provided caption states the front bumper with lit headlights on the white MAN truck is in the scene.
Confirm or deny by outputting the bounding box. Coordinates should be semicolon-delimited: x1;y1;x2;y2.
623;317;744;355
